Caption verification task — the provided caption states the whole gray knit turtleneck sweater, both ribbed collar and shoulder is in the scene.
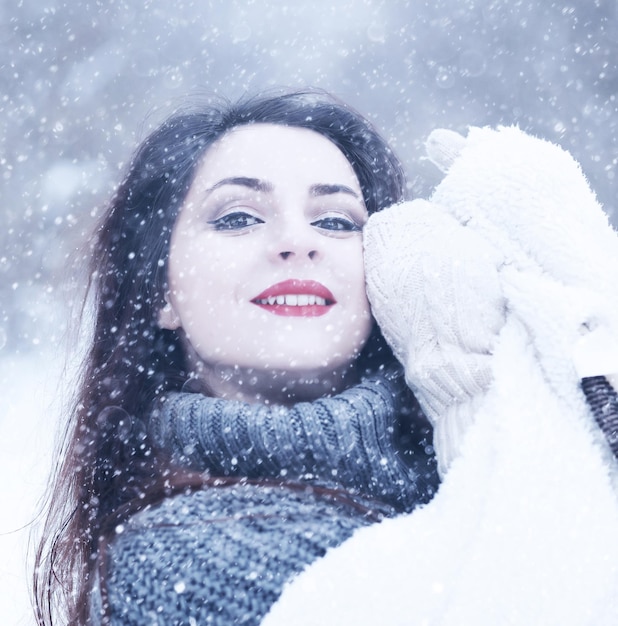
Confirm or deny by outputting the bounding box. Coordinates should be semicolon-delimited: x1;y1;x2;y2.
90;375;438;626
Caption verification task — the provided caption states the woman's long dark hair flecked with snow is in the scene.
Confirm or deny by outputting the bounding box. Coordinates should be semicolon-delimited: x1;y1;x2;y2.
34;90;405;625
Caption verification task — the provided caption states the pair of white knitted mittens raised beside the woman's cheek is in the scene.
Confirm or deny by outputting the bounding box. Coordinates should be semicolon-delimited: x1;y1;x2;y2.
364;127;618;473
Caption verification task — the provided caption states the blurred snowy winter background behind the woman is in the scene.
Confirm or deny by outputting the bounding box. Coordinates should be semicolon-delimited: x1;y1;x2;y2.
0;0;618;624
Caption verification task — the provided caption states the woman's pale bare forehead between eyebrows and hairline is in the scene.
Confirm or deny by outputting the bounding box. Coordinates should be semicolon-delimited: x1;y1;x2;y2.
190;124;359;190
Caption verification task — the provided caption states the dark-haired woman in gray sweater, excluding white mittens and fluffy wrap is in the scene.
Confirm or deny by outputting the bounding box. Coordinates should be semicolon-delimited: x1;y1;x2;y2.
35;92;437;624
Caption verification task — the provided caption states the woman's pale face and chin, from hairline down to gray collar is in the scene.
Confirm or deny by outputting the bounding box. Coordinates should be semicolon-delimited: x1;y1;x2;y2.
160;124;372;401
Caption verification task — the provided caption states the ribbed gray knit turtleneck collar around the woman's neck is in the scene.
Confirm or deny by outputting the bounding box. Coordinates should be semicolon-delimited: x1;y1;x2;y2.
150;368;436;511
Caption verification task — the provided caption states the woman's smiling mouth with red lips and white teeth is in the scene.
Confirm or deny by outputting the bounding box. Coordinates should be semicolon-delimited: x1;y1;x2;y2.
251;280;336;317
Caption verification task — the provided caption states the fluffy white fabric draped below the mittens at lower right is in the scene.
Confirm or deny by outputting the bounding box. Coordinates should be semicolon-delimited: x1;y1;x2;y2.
264;321;618;626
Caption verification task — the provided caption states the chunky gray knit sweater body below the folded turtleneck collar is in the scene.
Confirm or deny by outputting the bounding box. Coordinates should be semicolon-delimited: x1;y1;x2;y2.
96;484;370;626
